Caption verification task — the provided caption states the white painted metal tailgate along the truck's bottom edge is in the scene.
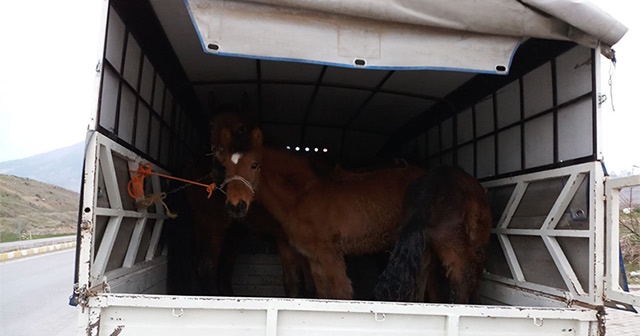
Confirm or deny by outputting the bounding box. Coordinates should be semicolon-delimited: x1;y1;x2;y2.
89;294;598;336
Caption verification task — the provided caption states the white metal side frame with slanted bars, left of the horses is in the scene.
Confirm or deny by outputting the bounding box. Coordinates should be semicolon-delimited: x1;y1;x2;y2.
77;132;168;298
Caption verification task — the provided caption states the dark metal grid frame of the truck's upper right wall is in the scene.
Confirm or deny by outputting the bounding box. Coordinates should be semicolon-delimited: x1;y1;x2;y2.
420;46;600;179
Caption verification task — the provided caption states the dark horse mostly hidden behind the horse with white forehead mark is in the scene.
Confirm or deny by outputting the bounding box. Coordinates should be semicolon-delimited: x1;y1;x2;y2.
186;104;313;297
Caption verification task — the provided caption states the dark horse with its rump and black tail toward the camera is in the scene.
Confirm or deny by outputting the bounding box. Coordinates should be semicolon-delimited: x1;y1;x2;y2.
375;167;492;303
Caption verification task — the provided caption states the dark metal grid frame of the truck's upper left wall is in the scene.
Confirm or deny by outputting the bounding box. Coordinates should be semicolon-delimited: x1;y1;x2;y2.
96;6;206;173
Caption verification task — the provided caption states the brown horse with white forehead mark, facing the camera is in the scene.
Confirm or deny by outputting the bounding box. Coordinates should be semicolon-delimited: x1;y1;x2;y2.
219;128;423;299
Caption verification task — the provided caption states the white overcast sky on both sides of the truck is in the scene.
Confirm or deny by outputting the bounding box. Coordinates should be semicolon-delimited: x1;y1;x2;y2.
0;0;640;174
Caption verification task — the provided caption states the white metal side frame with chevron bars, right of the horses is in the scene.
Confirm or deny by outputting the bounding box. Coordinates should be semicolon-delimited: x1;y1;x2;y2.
483;162;605;306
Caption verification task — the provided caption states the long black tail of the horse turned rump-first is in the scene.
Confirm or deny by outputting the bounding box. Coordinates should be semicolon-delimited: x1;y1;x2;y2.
374;179;427;302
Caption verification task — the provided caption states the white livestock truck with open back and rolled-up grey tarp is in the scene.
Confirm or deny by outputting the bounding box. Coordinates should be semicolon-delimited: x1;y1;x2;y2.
72;0;640;336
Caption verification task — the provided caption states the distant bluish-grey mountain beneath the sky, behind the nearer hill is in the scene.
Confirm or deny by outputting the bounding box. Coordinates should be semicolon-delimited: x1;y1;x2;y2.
0;143;84;192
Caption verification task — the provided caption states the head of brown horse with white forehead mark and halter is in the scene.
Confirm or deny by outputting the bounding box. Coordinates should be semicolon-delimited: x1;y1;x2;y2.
217;128;263;219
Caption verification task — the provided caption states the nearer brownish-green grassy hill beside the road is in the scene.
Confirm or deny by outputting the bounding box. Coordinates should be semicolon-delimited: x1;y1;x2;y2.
0;174;80;242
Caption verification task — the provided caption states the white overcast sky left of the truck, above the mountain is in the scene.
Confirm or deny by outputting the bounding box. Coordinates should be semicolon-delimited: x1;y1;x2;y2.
0;0;103;162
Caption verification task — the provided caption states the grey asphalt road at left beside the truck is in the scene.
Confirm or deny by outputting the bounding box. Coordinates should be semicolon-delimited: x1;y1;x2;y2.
0;249;78;336
